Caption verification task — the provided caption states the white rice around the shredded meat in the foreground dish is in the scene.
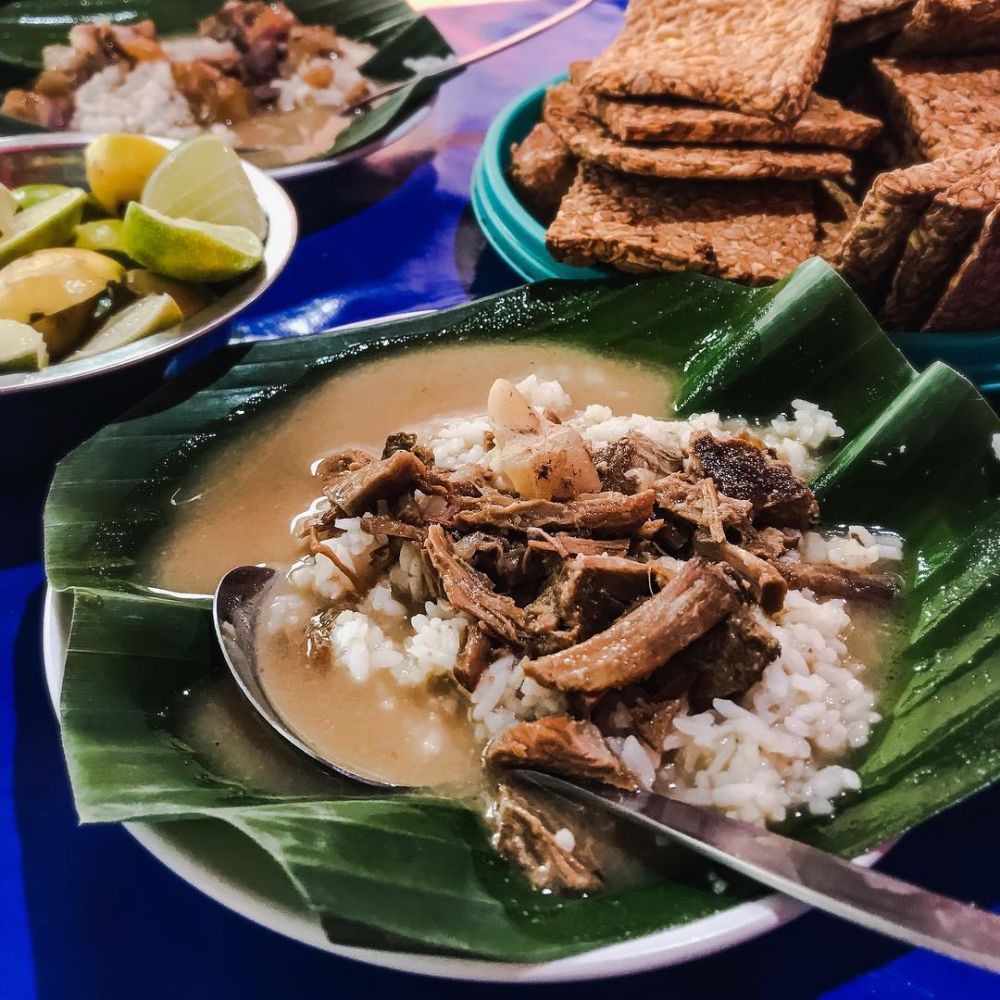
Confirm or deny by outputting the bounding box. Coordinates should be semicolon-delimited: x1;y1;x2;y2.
269;375;902;828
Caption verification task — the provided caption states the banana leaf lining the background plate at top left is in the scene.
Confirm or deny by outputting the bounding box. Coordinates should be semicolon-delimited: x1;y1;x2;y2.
0;0;452;159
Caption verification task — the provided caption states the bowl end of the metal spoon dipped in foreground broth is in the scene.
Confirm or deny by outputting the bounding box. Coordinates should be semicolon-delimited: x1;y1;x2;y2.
212;566;403;789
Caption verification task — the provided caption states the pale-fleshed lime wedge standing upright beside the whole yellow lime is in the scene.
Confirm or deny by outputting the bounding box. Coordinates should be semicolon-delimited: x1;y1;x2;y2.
141;135;267;239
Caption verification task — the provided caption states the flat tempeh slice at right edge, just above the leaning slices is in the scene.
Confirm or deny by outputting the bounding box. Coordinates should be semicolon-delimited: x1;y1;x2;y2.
872;55;1000;160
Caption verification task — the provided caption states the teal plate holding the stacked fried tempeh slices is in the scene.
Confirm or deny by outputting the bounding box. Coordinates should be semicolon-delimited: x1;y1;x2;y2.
472;76;1000;392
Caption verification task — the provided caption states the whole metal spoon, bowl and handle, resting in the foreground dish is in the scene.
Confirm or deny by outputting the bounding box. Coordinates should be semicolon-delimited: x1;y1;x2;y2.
214;566;1000;972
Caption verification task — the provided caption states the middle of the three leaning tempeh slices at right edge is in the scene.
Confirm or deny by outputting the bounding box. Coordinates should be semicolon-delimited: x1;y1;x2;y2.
882;170;1000;330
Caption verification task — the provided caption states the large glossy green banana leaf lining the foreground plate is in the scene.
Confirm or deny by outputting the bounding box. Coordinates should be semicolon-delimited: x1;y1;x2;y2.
45;260;1000;961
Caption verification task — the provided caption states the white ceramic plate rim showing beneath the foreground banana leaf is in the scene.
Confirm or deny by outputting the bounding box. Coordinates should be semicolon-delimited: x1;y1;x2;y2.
42;589;884;983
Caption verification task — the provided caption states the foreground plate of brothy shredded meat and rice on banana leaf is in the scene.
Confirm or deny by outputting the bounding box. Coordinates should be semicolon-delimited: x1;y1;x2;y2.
37;259;1000;980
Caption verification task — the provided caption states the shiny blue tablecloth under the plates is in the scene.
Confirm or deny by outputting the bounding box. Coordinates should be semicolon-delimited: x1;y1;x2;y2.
0;2;1000;1000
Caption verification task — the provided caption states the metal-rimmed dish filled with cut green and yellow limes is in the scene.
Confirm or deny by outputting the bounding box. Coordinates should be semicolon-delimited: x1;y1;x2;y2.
0;133;297;394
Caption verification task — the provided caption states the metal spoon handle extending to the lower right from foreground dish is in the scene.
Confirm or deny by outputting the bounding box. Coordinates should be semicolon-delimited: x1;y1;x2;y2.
516;771;1000;972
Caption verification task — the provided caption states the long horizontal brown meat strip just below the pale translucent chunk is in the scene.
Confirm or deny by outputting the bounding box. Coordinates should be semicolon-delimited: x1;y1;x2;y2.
453;490;653;535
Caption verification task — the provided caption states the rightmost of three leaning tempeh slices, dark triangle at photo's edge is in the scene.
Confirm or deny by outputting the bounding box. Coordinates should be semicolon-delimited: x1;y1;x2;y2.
924;208;1000;330
